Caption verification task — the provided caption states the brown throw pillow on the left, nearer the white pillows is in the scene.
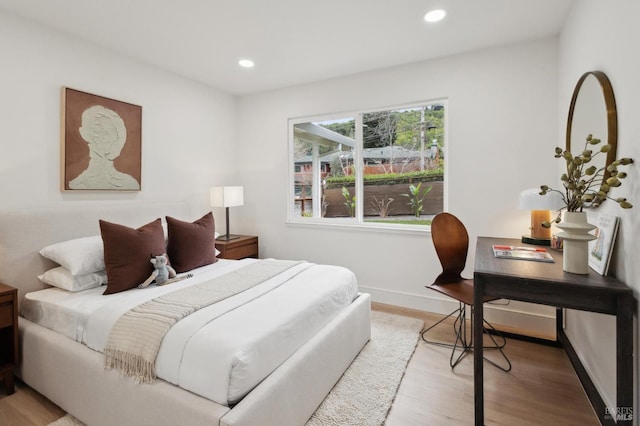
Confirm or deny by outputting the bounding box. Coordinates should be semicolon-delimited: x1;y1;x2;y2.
100;219;165;294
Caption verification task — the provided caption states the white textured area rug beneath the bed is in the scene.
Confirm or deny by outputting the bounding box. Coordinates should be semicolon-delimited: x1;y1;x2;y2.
49;311;423;426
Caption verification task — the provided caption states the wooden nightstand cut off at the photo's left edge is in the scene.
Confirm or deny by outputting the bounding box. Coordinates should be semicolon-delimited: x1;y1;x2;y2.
0;284;18;395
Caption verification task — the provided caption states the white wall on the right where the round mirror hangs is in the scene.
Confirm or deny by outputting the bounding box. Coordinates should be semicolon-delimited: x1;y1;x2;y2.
559;0;640;425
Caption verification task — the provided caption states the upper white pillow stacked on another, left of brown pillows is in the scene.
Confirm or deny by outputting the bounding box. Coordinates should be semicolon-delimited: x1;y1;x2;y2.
40;235;105;275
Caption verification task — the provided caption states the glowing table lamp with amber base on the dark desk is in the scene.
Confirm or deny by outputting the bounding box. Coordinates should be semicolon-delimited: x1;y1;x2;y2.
518;188;565;246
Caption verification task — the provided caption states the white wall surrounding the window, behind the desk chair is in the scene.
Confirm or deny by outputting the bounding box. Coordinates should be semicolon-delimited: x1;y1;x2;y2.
238;39;559;334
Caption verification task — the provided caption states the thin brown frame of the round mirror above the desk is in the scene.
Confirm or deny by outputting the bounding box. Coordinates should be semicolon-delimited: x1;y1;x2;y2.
565;71;618;182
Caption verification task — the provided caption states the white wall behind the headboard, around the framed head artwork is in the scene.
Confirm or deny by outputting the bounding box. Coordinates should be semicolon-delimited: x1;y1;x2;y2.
0;13;235;214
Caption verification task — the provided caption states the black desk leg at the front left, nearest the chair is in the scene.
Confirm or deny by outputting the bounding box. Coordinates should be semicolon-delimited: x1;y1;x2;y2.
473;276;484;426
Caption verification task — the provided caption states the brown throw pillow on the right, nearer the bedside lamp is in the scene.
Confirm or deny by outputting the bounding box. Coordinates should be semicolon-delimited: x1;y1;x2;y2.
167;212;217;273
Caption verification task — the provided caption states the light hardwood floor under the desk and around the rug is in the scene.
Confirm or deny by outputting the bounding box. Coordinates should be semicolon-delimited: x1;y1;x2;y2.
0;303;600;426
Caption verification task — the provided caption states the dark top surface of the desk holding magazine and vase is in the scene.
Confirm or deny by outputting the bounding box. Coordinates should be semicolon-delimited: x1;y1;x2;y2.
474;237;631;293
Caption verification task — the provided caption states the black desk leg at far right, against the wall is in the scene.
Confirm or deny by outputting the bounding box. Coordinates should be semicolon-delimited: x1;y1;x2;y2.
614;294;637;425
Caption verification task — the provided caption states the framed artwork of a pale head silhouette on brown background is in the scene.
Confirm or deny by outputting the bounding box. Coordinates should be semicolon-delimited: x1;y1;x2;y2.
62;87;142;191
